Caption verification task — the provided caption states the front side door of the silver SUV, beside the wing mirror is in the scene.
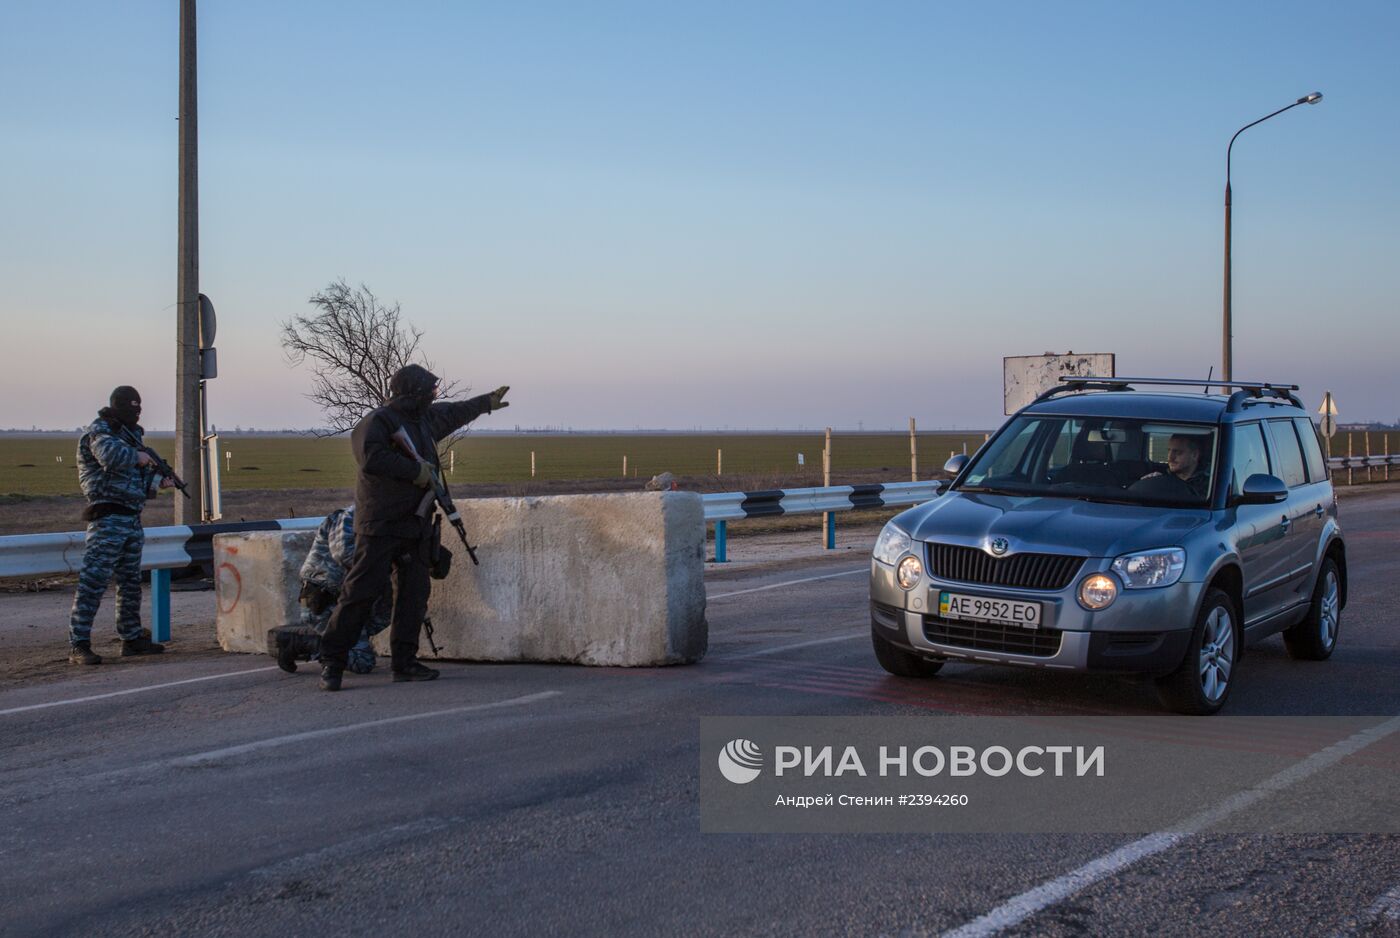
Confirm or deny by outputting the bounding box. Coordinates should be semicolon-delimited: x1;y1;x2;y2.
1229;421;1288;626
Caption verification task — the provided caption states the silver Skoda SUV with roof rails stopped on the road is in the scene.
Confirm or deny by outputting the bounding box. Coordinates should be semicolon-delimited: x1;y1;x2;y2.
871;378;1347;714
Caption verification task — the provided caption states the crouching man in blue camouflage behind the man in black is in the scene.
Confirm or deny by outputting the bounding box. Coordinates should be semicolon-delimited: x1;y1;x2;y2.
267;505;393;675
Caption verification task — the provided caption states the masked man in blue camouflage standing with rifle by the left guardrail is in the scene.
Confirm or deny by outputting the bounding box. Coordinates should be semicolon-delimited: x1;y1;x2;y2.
69;385;174;665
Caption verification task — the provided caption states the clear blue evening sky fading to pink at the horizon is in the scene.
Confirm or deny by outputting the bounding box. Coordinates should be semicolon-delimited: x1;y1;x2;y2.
0;0;1400;430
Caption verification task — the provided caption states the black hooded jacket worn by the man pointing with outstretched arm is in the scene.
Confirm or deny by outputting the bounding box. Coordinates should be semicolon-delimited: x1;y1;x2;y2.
350;395;491;538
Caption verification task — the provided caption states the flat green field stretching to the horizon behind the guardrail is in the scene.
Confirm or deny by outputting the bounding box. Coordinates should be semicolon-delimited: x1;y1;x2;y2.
0;433;983;496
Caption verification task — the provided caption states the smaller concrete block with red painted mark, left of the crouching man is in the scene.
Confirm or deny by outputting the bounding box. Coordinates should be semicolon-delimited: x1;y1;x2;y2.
214;531;316;654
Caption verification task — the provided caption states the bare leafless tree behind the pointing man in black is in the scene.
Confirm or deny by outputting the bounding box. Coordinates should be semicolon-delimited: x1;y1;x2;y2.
281;279;456;445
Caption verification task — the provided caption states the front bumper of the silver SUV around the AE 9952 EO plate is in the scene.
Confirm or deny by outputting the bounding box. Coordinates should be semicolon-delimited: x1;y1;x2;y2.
871;559;1201;673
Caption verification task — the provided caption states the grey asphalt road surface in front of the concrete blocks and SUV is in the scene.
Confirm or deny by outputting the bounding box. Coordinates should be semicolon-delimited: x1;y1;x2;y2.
0;493;1400;937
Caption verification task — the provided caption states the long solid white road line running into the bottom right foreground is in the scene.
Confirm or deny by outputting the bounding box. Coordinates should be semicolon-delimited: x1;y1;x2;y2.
944;717;1400;938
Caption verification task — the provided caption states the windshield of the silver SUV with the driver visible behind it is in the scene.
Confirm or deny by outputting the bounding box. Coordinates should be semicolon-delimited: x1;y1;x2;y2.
958;414;1217;508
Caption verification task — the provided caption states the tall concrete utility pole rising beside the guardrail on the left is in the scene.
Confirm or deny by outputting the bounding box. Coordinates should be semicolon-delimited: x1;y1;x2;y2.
175;0;204;525
